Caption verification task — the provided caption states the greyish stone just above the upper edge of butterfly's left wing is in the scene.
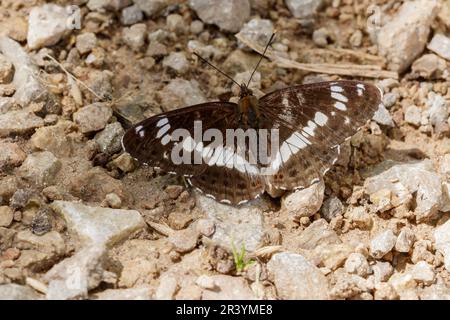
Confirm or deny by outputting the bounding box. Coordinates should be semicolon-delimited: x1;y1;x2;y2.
159;78;206;111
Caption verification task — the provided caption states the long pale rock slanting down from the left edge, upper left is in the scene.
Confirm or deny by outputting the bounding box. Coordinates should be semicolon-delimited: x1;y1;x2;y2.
0;36;47;106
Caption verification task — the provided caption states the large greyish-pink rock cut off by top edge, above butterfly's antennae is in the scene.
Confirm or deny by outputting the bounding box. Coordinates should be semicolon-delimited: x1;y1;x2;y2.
189;0;250;32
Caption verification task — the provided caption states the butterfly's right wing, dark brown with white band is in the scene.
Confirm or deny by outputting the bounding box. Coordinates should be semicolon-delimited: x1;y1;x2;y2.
259;81;381;191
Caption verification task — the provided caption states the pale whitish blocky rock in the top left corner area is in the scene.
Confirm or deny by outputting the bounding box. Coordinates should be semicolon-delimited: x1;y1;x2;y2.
27;4;71;50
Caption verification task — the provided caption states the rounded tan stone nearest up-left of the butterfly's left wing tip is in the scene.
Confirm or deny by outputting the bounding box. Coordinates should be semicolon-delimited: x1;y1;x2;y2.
73;102;112;133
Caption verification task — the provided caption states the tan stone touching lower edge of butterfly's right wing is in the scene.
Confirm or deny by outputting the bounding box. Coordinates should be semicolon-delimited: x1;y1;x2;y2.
281;181;325;220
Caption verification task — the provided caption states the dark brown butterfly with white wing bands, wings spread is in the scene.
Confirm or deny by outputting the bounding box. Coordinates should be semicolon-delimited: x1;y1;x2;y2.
122;36;381;205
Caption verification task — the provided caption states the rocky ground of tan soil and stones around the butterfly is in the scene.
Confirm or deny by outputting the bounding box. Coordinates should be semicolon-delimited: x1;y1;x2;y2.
0;0;450;300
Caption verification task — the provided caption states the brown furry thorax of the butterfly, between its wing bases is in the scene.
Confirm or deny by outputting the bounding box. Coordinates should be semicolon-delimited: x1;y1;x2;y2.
238;84;261;128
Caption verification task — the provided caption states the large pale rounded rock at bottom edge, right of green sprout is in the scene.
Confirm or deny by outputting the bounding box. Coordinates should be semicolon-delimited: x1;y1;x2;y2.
267;252;328;300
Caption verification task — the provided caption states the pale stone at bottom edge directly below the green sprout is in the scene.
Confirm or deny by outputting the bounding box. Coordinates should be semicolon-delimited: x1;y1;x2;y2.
202;275;255;300
